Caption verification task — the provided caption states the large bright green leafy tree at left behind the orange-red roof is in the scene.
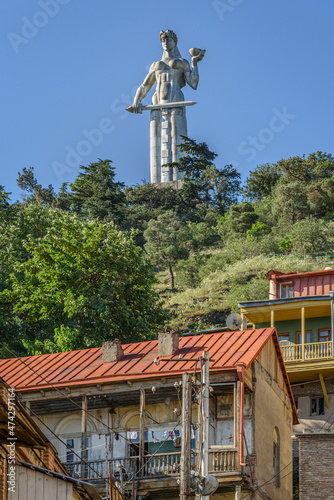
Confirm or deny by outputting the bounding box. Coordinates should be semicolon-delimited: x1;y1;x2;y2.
0;206;167;352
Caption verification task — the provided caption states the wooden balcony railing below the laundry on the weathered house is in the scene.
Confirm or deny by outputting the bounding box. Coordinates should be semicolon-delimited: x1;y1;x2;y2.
64;448;239;481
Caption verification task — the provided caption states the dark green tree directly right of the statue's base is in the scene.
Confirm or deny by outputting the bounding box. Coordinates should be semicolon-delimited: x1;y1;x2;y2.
170;136;240;218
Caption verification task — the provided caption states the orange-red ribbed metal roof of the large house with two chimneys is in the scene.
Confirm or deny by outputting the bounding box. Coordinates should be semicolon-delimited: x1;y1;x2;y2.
0;328;285;391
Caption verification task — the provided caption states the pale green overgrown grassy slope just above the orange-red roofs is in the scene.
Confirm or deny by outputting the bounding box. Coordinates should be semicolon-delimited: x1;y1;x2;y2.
158;255;331;332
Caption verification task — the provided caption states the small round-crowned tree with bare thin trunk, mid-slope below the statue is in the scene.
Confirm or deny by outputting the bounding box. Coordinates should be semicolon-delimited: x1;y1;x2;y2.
144;210;189;289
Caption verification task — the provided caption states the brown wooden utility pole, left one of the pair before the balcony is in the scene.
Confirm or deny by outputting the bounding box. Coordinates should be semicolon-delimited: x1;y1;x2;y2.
180;372;192;500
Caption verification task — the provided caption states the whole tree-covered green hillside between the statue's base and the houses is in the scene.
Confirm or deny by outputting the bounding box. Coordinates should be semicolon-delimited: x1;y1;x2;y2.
0;145;334;356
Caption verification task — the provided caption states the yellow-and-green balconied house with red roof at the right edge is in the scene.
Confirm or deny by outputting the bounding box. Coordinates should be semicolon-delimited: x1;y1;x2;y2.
239;269;334;499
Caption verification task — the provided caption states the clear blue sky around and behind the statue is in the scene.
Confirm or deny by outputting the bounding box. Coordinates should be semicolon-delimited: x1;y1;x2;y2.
0;0;334;200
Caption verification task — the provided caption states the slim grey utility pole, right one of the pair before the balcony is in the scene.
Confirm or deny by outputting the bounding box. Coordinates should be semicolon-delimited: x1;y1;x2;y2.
200;351;210;500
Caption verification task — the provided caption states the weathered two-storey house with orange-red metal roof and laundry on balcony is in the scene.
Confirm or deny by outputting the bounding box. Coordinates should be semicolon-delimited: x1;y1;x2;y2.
0;328;297;500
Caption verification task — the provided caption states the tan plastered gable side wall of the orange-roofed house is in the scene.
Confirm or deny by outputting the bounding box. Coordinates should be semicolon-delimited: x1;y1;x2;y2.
253;339;292;500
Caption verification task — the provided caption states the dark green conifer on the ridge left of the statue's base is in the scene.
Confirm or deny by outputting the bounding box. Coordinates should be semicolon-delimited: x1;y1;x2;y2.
70;160;125;224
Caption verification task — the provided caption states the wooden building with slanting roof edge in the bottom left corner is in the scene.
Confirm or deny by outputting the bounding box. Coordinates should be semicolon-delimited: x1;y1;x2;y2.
0;378;103;500
